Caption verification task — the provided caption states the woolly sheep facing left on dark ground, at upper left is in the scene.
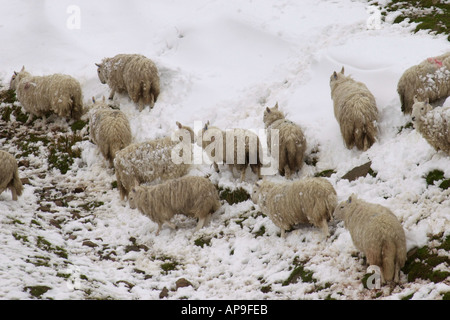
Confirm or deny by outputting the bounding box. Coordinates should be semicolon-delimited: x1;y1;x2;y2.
10;67;84;120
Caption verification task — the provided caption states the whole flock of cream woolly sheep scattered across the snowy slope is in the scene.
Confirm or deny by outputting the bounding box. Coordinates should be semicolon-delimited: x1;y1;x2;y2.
0;52;450;283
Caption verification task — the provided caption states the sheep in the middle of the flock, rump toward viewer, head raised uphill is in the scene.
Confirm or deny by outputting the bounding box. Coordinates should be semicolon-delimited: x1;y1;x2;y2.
263;103;307;179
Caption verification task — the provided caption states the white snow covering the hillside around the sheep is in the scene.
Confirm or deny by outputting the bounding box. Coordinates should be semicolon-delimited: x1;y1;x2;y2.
0;0;450;299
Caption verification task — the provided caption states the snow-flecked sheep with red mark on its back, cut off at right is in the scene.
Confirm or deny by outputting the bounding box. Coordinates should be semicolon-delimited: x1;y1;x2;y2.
397;51;450;114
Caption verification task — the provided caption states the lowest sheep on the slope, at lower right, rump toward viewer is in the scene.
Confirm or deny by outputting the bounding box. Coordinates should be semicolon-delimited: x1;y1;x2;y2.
333;194;406;284
